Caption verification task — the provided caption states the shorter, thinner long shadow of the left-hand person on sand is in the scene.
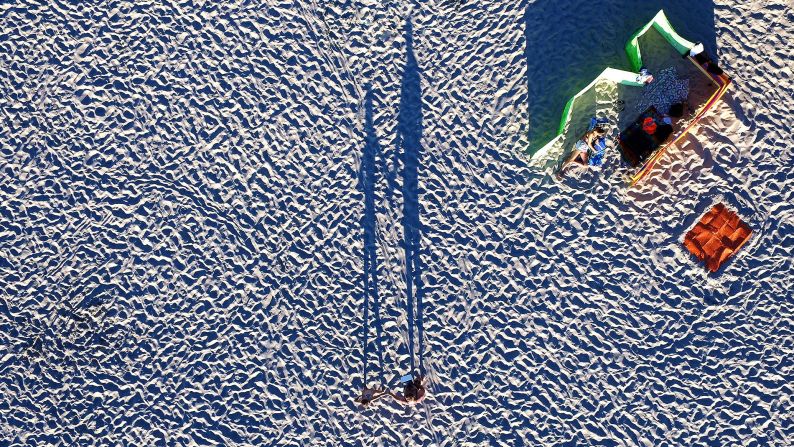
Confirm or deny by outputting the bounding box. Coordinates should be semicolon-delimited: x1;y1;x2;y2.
358;88;385;386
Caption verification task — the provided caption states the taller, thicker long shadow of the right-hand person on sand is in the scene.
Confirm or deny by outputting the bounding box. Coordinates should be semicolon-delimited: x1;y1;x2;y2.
397;18;424;371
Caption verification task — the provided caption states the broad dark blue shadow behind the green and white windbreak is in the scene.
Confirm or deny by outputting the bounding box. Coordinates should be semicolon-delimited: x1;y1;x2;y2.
524;0;717;153
